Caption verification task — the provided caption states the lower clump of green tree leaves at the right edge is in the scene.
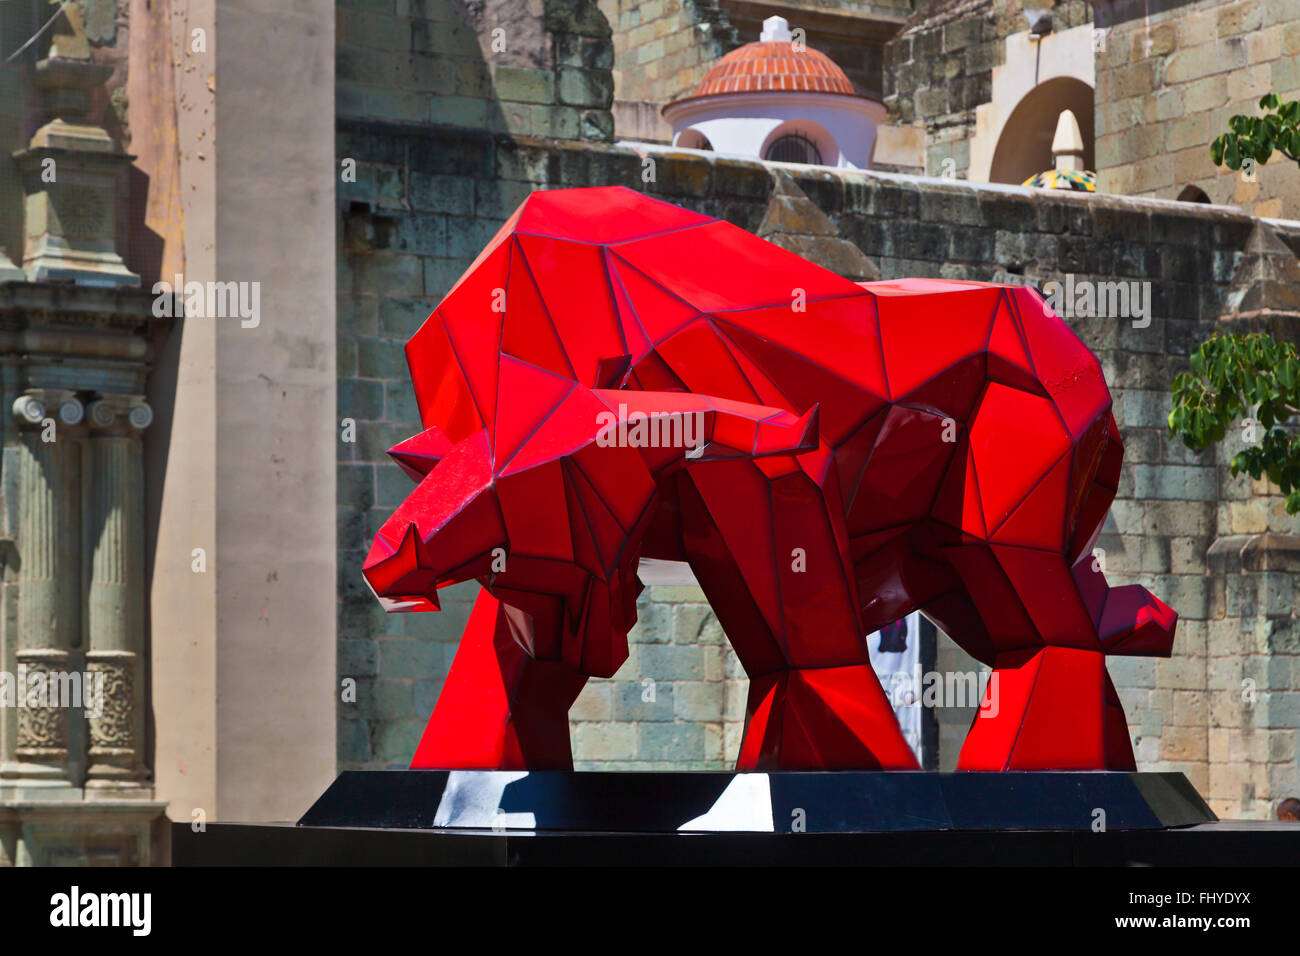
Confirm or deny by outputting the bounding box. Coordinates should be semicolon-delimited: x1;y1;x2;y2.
1169;332;1300;515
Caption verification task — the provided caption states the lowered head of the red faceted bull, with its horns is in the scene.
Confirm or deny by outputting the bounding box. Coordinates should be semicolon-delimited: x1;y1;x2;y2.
363;382;818;676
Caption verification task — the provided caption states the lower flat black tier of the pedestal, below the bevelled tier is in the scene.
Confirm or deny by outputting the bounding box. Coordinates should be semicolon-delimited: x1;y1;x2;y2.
172;821;1300;868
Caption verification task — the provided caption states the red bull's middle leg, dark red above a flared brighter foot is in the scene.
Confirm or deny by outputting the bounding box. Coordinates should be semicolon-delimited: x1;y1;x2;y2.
679;453;918;770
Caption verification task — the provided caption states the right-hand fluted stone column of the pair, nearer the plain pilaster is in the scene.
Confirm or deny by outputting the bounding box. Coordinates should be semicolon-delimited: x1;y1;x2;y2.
85;395;153;790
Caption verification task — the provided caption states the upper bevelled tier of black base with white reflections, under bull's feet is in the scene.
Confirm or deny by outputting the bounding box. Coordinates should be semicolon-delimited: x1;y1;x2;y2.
299;770;1216;834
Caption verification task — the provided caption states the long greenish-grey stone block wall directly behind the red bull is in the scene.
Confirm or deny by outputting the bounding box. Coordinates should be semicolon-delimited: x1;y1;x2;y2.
338;115;1300;816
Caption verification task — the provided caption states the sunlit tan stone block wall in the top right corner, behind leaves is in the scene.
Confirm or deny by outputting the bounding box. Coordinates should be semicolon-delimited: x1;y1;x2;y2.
1096;0;1300;219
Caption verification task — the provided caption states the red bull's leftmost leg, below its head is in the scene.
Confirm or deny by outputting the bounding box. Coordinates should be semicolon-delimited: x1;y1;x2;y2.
411;589;586;770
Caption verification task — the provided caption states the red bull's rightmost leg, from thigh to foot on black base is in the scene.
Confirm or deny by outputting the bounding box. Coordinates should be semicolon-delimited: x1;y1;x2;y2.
923;382;1177;770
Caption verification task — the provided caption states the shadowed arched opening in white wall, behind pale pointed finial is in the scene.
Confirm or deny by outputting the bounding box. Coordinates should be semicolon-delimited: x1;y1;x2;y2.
988;77;1097;186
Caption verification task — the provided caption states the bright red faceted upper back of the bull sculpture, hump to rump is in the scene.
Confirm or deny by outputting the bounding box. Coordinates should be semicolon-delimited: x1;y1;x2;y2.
407;187;1109;504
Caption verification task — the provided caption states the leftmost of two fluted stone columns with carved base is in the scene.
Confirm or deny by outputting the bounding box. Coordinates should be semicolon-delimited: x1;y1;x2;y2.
0;390;83;788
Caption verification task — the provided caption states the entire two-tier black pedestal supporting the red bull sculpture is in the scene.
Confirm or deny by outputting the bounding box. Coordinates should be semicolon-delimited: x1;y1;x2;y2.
172;770;1300;868
